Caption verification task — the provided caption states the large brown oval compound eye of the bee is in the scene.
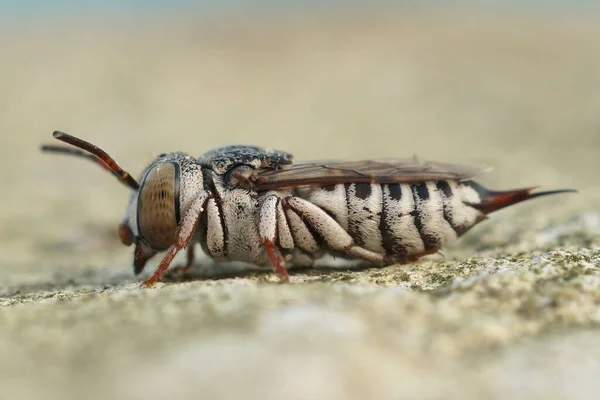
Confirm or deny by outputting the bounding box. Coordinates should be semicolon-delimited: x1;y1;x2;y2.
137;162;179;250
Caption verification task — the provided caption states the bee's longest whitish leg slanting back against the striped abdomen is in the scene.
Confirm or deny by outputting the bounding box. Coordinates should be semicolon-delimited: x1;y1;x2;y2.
283;196;385;265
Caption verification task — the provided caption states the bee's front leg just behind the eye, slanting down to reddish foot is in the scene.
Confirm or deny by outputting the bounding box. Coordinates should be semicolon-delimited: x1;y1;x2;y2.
140;192;209;287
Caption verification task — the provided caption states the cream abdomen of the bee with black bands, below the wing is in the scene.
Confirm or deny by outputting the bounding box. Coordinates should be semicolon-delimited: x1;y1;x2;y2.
306;181;484;256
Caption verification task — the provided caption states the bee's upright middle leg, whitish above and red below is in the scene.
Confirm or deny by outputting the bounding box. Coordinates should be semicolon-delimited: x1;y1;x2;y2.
258;196;290;283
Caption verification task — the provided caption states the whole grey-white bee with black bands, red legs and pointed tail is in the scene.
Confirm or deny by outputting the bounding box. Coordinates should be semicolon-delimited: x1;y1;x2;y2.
41;131;574;287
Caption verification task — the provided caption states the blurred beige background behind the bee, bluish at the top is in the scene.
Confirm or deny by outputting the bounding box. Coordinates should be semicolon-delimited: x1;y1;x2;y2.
0;0;600;396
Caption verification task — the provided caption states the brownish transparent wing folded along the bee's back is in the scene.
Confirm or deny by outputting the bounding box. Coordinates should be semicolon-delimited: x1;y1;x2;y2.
251;159;489;190
